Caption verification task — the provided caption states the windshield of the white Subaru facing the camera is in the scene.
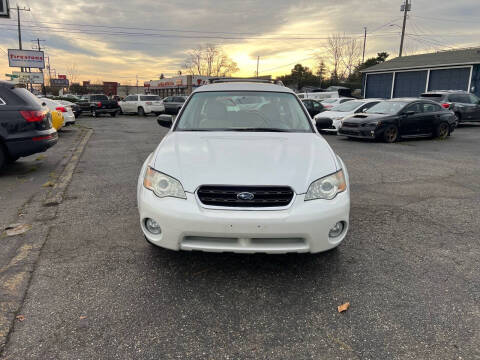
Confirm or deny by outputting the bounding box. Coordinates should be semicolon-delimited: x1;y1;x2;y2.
176;91;313;132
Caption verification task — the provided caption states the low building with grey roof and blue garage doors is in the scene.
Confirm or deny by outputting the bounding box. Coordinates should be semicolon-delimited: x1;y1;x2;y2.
362;48;480;99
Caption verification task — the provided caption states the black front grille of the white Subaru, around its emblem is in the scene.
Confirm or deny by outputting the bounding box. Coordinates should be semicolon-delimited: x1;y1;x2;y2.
197;185;293;208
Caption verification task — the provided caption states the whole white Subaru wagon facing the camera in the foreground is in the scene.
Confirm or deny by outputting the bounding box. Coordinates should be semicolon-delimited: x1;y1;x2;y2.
137;81;350;253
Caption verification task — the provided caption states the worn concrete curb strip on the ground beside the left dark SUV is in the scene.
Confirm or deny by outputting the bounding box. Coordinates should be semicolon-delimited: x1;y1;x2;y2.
43;129;93;206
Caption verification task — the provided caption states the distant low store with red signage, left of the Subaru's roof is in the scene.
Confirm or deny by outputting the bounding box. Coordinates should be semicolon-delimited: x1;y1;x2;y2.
144;75;209;97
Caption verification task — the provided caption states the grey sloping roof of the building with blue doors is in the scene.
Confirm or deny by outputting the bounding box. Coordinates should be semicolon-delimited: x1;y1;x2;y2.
361;47;480;73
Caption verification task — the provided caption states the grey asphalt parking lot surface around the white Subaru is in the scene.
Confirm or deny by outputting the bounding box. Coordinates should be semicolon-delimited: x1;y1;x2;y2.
3;116;480;359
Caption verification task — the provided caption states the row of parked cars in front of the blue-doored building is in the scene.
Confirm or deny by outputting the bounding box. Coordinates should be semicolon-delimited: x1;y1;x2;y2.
303;90;480;142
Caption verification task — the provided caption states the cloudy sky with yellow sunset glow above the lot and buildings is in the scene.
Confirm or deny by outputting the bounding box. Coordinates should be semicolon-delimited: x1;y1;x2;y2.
0;0;480;85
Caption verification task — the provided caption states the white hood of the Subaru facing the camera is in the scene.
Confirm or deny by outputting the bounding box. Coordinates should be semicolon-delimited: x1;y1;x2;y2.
150;131;339;194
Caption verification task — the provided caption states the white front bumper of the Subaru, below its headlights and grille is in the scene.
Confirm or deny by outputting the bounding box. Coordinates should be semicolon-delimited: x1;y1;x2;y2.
137;184;350;253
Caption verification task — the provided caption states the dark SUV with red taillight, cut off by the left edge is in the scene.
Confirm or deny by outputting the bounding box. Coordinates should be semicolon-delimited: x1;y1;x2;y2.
0;81;58;169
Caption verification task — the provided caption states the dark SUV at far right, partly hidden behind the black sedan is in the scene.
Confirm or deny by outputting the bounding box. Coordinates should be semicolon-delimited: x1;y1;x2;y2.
420;90;480;124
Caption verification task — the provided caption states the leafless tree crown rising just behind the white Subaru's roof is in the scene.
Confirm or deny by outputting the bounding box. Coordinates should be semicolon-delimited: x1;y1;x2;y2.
184;44;239;76
